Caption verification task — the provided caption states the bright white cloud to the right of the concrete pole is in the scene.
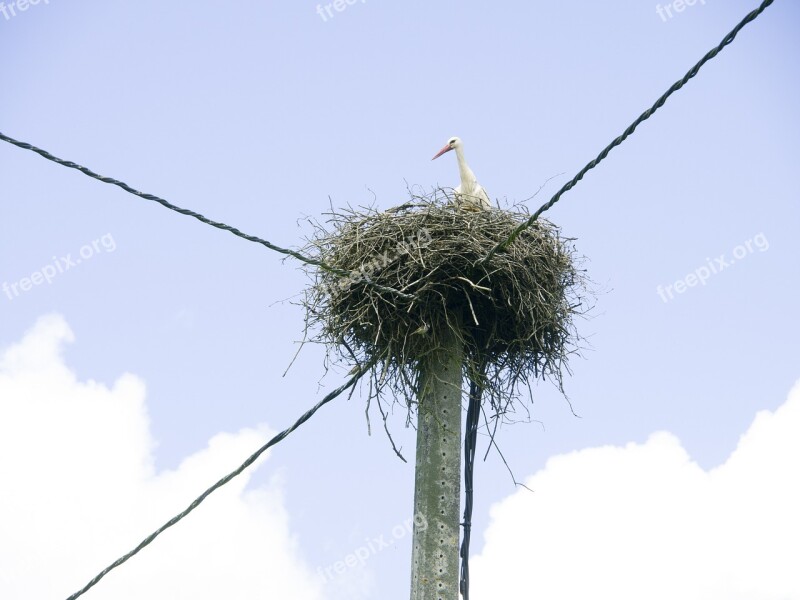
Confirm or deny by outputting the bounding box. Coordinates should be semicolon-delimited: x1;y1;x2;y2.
470;383;800;600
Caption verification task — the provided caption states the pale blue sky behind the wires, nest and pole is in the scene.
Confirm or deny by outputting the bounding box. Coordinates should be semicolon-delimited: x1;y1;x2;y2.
0;0;800;600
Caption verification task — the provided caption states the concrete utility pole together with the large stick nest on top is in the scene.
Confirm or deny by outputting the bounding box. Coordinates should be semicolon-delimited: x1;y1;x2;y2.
306;196;585;600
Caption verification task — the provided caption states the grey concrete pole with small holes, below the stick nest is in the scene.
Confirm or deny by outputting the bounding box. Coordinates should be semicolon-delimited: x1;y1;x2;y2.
411;327;464;600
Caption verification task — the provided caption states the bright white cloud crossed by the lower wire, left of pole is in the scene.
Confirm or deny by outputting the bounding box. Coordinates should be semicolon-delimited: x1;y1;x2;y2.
0;316;321;600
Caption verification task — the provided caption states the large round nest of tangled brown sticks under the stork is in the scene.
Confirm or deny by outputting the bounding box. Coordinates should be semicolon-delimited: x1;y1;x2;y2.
304;189;586;419
